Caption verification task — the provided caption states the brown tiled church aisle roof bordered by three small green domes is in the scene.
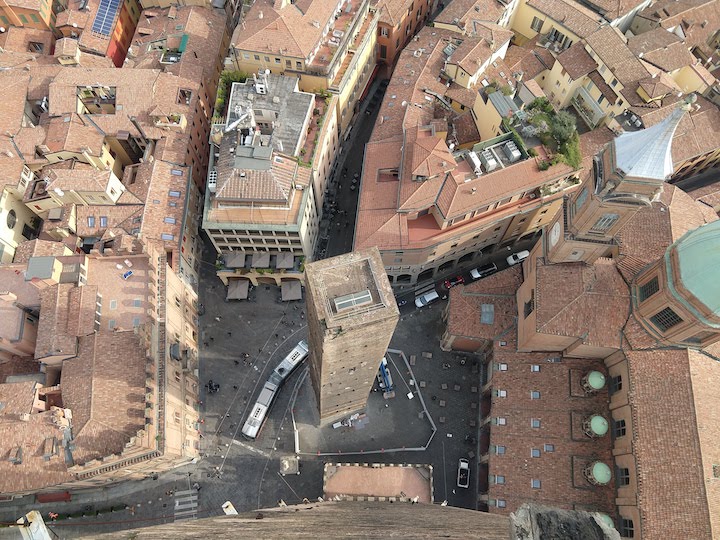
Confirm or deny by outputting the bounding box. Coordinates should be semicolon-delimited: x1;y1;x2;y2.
481;348;615;515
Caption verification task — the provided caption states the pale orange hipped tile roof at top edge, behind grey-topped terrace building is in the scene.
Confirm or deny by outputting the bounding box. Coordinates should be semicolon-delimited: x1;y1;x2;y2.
233;0;342;58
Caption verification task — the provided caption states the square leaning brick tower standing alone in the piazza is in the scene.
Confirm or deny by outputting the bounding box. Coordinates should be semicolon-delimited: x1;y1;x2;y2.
305;249;399;424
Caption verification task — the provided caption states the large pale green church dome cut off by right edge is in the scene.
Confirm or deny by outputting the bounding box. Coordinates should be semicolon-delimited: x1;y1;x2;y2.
670;221;720;315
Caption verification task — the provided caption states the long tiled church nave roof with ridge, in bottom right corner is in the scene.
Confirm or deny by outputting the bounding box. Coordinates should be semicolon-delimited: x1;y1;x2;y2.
625;349;719;539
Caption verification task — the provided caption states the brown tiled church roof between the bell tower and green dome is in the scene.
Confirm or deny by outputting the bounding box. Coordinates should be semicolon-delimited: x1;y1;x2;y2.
535;259;630;348
